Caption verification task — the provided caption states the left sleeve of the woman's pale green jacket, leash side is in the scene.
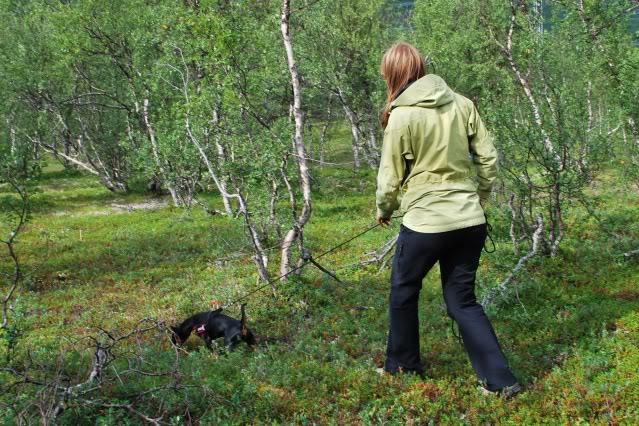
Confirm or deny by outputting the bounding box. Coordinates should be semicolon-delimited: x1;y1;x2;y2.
376;127;411;219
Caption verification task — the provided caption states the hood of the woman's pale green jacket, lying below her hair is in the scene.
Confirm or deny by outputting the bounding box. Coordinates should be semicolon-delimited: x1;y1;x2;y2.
391;74;454;110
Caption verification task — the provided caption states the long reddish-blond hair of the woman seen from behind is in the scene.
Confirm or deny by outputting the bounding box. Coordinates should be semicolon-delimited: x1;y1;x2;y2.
380;43;426;129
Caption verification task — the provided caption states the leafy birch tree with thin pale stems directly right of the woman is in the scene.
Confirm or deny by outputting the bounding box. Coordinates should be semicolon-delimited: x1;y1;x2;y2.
415;0;614;256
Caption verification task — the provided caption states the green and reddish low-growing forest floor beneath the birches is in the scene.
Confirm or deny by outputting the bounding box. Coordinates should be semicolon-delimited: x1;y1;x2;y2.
0;136;639;424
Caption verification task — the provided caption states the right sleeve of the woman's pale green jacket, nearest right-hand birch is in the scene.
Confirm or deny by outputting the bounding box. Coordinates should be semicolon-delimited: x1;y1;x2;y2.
468;105;498;200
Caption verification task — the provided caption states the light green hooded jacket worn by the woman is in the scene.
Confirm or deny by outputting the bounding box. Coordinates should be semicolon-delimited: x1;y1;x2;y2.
377;74;497;233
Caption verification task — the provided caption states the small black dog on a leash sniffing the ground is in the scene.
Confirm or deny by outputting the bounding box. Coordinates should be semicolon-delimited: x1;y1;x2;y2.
171;304;255;350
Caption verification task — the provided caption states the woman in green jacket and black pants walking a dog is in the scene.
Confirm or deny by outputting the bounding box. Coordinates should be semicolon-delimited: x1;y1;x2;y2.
377;43;521;396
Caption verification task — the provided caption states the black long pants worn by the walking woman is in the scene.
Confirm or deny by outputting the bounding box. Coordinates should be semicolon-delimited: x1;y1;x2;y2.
384;225;516;390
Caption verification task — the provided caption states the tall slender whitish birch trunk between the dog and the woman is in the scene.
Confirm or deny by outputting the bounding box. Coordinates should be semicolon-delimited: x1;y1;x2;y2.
280;0;312;275
